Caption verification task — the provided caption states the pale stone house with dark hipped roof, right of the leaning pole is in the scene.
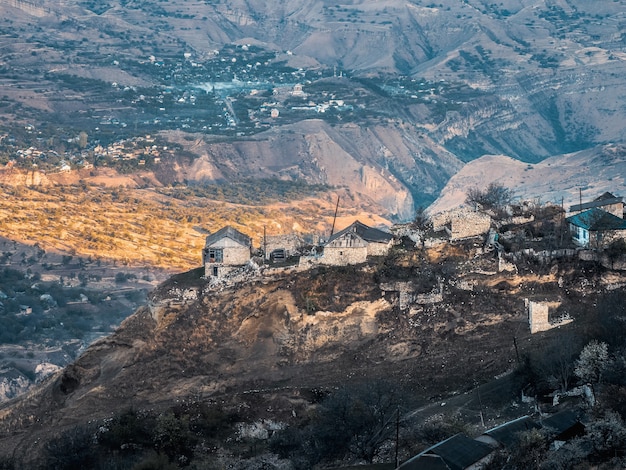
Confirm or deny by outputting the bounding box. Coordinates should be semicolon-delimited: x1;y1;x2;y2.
320;220;393;266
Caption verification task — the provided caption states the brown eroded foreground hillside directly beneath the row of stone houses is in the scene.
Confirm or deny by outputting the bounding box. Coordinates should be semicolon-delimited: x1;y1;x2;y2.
0;243;621;468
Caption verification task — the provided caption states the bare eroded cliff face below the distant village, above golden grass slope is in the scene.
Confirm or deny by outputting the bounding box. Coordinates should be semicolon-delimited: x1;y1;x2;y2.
161;120;462;220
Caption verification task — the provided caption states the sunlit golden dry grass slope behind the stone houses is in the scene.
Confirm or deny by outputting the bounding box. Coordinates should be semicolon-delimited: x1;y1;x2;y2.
0;183;352;270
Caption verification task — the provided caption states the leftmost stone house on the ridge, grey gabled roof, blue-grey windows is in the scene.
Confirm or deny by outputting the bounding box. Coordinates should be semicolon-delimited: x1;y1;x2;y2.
202;226;252;277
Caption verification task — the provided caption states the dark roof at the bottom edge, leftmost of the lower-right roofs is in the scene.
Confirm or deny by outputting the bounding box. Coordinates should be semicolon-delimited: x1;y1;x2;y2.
398;434;493;470
